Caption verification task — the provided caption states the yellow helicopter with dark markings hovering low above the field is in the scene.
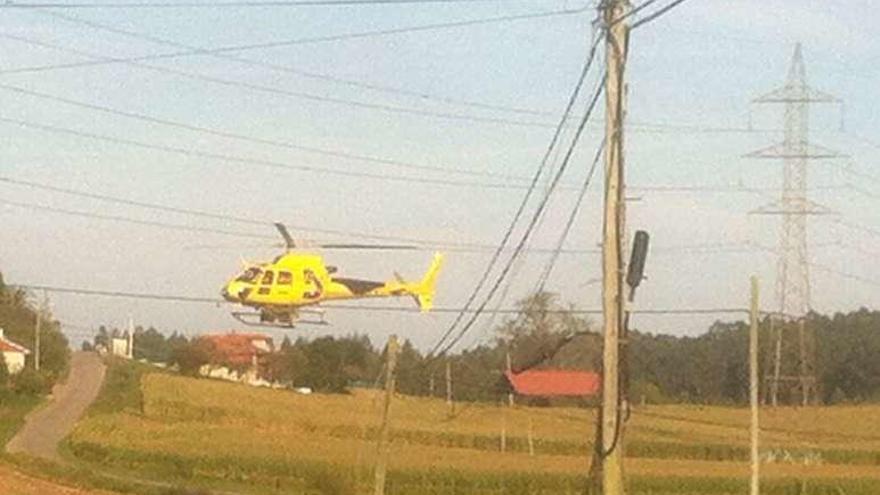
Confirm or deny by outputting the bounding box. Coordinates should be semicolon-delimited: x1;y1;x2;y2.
220;223;443;327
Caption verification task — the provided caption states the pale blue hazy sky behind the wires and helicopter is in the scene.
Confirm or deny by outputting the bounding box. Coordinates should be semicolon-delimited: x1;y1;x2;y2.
0;0;880;349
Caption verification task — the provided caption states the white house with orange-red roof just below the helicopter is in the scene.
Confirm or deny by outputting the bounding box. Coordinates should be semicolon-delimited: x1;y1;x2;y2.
199;330;275;386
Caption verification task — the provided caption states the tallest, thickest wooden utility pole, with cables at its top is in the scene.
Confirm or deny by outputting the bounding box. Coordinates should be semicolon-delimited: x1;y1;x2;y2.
598;0;630;495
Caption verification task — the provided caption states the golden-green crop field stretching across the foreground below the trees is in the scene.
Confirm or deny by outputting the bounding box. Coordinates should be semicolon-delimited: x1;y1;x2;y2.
66;367;880;495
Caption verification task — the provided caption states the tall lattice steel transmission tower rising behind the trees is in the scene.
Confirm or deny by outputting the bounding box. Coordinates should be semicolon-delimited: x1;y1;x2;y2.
749;43;840;405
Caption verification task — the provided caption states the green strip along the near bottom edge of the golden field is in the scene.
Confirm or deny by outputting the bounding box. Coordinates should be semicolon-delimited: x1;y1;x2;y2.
63;444;878;495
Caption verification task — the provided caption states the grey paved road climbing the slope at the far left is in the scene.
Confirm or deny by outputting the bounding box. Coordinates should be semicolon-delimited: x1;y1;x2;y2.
6;352;105;461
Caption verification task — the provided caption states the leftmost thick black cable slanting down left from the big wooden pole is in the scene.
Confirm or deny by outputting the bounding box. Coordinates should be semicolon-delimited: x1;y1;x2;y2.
428;30;601;355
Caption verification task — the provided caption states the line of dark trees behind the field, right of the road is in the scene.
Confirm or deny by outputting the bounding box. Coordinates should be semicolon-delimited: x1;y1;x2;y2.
87;293;880;405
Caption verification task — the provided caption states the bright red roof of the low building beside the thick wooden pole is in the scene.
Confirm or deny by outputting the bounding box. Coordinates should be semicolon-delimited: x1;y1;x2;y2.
504;370;602;397
